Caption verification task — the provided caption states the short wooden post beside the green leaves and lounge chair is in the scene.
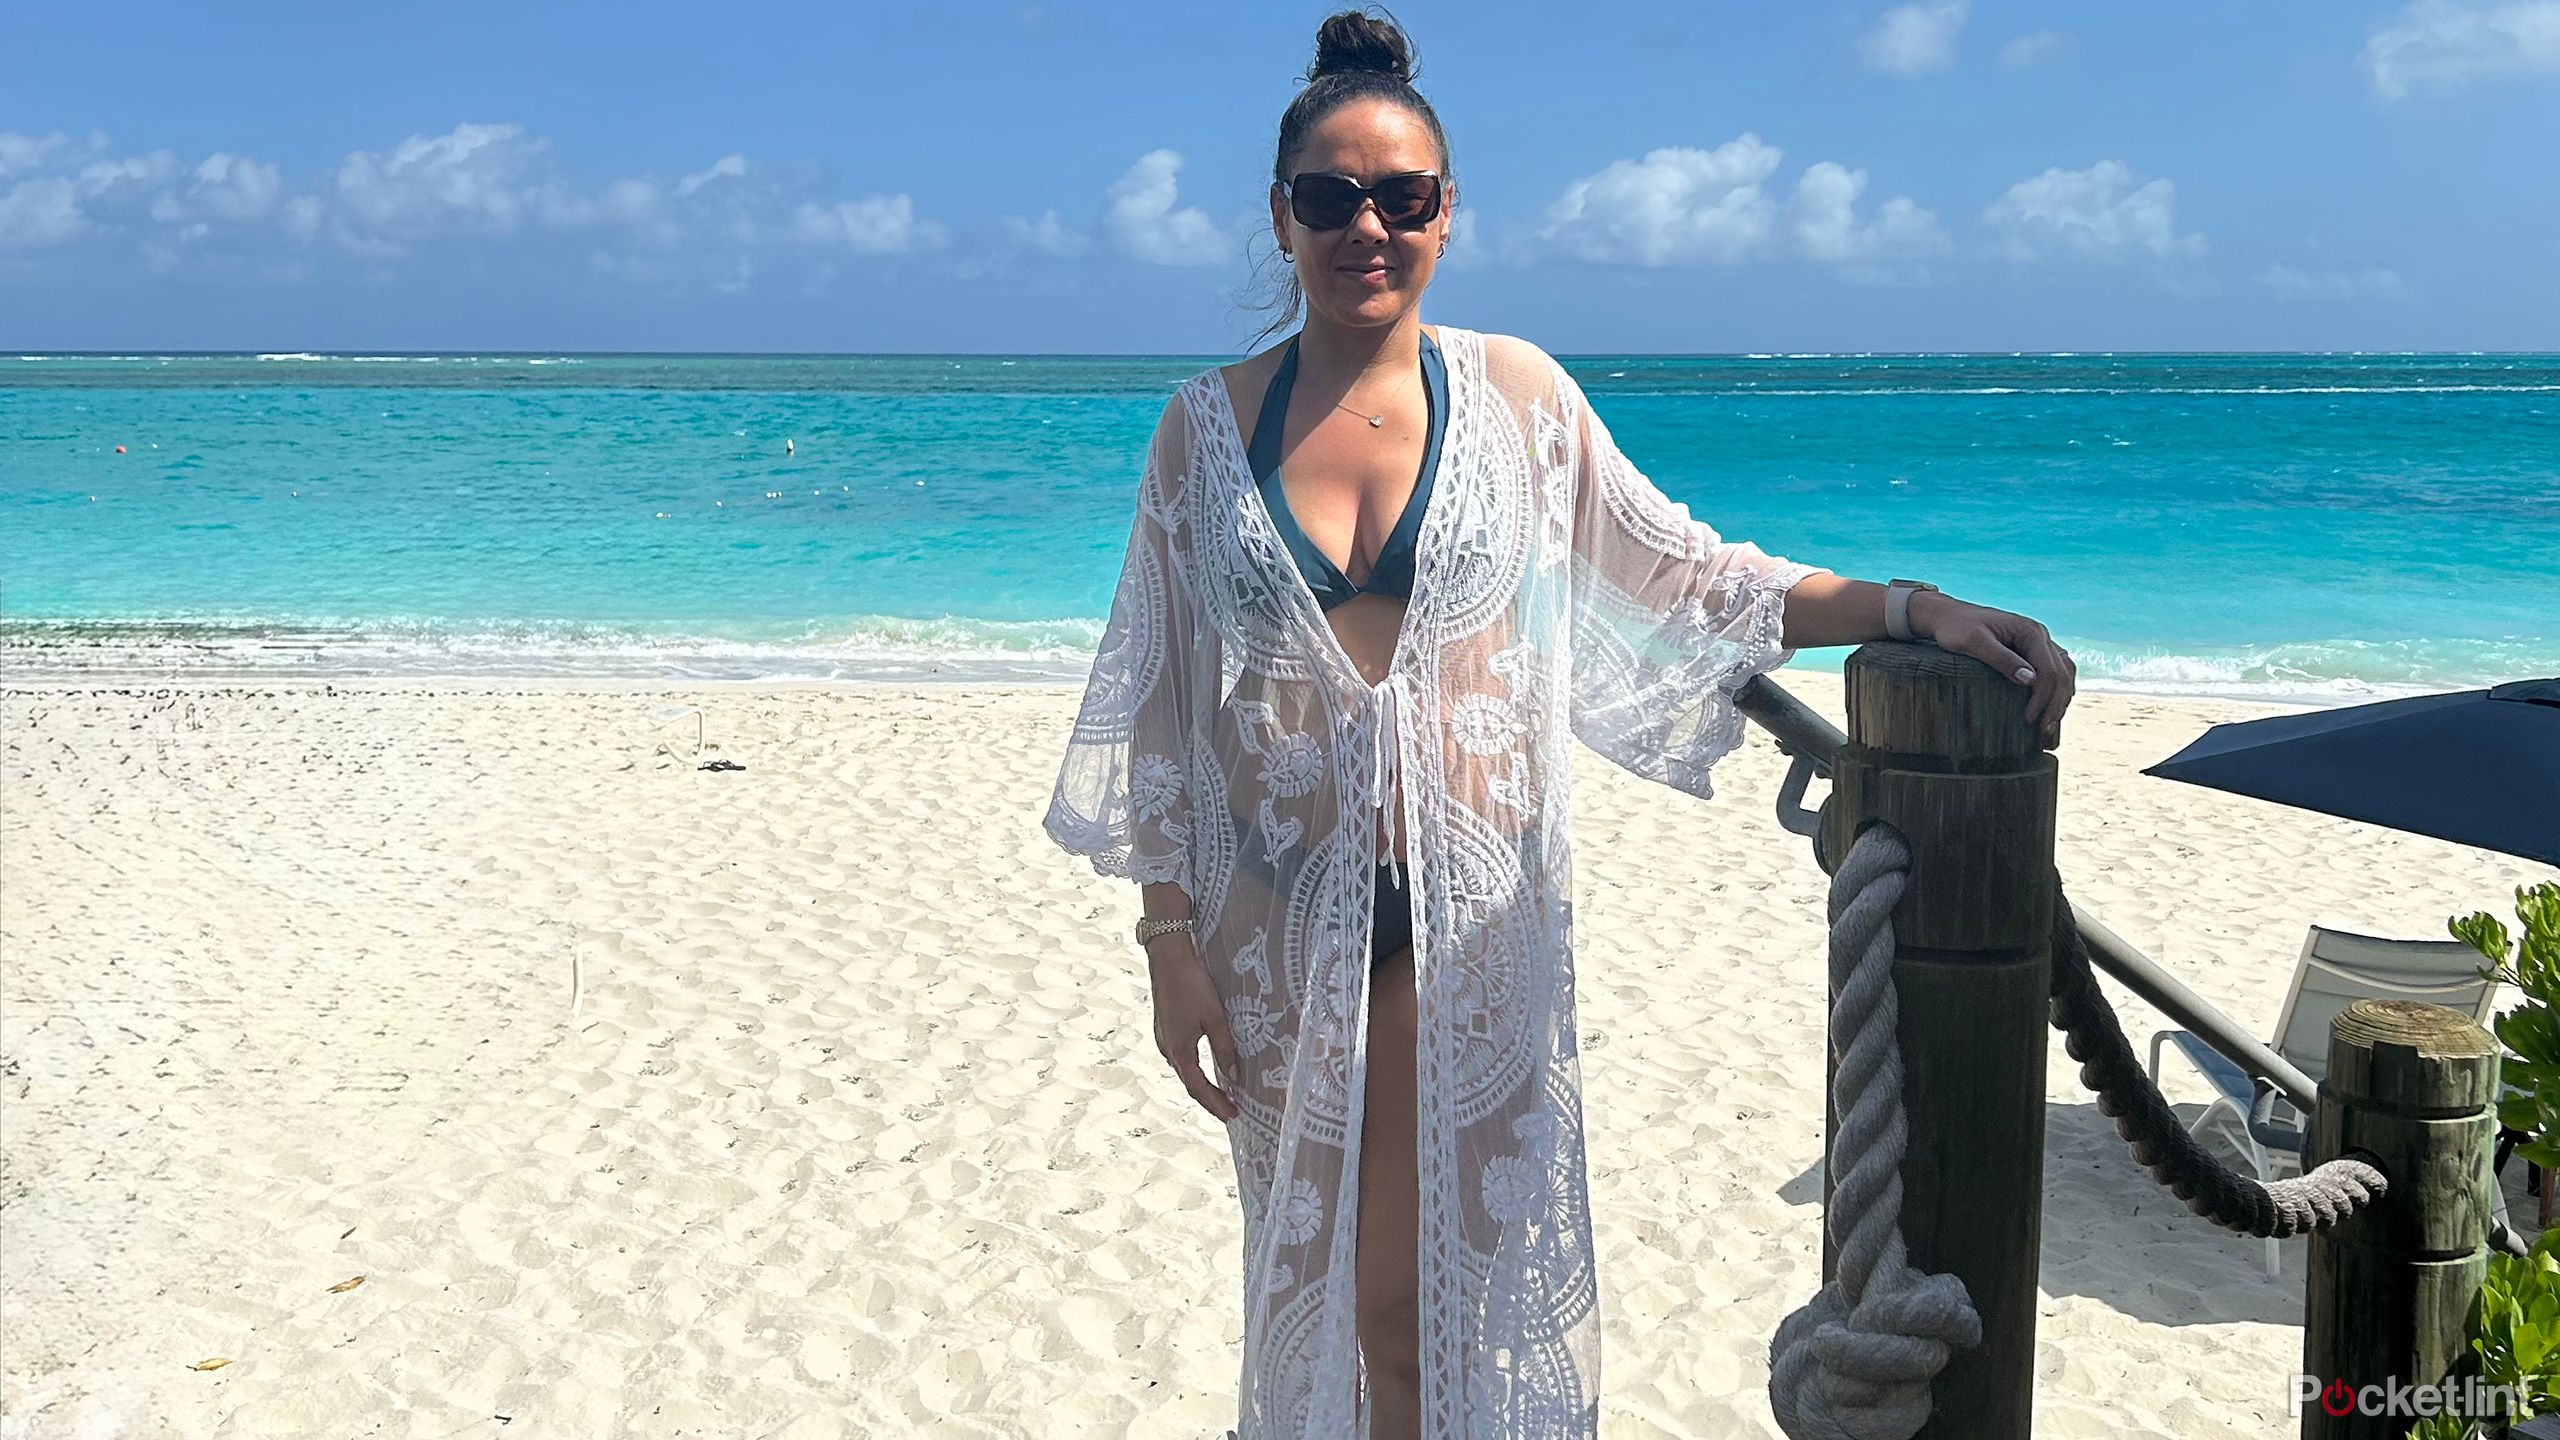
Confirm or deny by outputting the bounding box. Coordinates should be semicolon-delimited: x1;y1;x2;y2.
2301;999;2499;1440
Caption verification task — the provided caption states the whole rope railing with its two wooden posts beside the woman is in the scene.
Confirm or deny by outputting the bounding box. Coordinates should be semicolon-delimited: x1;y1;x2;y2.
1738;646;2522;1440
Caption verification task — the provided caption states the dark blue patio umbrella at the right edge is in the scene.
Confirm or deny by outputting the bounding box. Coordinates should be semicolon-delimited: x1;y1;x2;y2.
2143;679;2560;866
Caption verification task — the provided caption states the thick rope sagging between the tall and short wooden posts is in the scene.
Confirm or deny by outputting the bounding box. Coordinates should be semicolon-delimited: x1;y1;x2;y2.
2053;879;2391;1240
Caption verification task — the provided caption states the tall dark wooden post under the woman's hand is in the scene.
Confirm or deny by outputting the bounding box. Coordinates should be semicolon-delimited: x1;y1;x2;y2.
1823;643;2056;1440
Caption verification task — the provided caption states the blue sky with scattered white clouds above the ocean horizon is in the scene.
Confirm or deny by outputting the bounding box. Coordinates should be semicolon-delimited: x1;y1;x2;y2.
0;0;2560;354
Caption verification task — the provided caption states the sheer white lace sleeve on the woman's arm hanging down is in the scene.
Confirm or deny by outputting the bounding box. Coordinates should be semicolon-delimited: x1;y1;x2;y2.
1044;397;1219;894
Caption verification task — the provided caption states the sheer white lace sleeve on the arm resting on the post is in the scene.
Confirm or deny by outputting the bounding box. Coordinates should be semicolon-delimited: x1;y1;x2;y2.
1549;351;1820;797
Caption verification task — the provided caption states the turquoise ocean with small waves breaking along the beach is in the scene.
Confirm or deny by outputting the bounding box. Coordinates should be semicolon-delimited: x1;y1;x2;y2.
0;354;2560;702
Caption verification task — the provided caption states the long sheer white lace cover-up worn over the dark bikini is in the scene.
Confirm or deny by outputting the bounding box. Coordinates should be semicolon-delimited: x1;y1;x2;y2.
1047;325;1812;1440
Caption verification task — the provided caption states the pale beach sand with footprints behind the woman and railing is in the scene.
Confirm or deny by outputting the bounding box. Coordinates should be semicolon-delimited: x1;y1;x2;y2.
0;674;2534;1440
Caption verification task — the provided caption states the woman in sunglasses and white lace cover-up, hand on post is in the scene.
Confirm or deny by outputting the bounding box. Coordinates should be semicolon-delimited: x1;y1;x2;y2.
1047;13;2071;1440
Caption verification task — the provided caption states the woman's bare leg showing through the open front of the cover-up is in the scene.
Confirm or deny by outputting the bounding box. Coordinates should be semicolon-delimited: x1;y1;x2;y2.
1352;948;1423;1440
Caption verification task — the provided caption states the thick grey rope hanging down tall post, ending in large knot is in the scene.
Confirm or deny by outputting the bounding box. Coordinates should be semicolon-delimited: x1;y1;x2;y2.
1769;825;1981;1440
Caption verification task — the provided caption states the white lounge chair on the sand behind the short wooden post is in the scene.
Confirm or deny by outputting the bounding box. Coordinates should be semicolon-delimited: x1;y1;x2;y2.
2150;925;2506;1276
